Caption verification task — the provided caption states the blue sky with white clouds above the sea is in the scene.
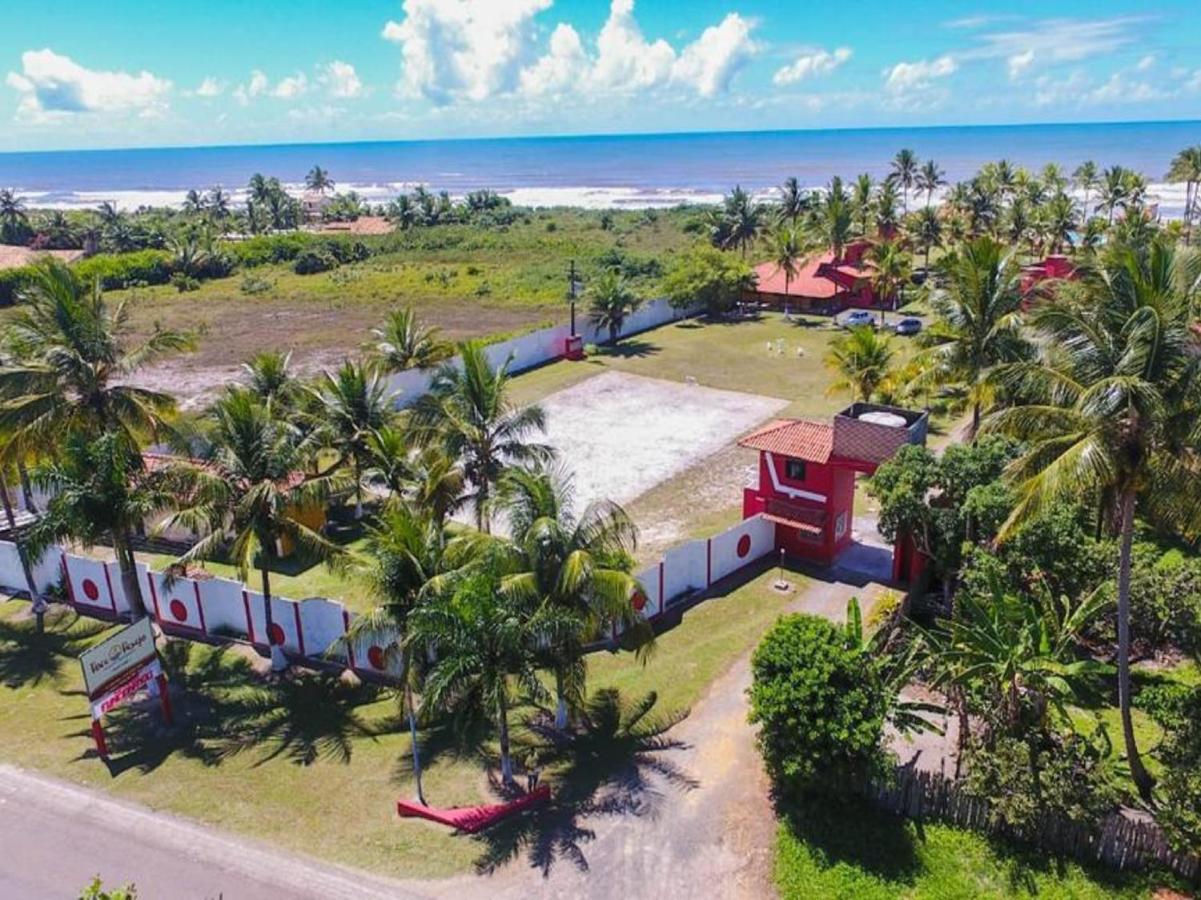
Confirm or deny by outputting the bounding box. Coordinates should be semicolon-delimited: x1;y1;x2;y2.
0;0;1201;150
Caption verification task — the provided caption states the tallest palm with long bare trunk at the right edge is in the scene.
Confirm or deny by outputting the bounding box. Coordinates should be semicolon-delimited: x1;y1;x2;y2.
988;243;1201;798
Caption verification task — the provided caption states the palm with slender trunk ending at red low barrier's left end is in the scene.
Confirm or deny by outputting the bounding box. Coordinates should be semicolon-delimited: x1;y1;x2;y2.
346;503;447;805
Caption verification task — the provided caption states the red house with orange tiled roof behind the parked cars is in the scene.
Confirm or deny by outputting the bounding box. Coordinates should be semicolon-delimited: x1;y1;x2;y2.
747;240;879;312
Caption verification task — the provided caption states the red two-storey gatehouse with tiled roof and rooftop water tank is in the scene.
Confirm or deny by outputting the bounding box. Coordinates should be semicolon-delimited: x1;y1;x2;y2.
739;403;930;580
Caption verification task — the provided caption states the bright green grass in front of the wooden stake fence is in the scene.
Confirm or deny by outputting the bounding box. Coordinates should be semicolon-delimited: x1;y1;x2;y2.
776;804;1161;900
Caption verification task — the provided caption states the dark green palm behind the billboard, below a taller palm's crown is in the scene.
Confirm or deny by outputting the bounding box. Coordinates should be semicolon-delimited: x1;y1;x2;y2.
28;430;173;620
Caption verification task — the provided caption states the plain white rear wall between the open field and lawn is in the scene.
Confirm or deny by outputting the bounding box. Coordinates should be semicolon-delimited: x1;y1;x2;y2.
388;297;692;406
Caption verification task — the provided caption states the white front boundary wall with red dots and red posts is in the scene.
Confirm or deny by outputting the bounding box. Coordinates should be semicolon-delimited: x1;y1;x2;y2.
0;517;775;678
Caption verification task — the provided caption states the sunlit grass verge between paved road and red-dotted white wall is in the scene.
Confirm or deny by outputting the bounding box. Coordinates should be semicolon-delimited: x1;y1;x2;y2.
0;562;811;877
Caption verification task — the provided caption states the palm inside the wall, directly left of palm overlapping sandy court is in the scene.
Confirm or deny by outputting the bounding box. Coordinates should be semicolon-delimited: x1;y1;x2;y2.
309;360;393;519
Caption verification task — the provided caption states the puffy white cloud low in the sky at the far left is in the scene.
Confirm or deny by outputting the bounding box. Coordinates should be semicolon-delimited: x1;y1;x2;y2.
5;48;172;119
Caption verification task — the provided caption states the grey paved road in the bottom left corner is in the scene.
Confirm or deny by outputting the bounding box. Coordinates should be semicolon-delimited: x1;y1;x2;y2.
0;764;429;900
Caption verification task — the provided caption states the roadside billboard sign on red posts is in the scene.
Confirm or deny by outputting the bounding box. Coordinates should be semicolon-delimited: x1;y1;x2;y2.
79;616;173;758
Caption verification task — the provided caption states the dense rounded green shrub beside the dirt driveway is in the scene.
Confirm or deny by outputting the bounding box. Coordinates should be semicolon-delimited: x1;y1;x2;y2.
751;615;889;797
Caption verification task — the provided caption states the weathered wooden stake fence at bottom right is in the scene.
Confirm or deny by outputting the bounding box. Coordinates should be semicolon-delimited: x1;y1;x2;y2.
864;768;1201;881
